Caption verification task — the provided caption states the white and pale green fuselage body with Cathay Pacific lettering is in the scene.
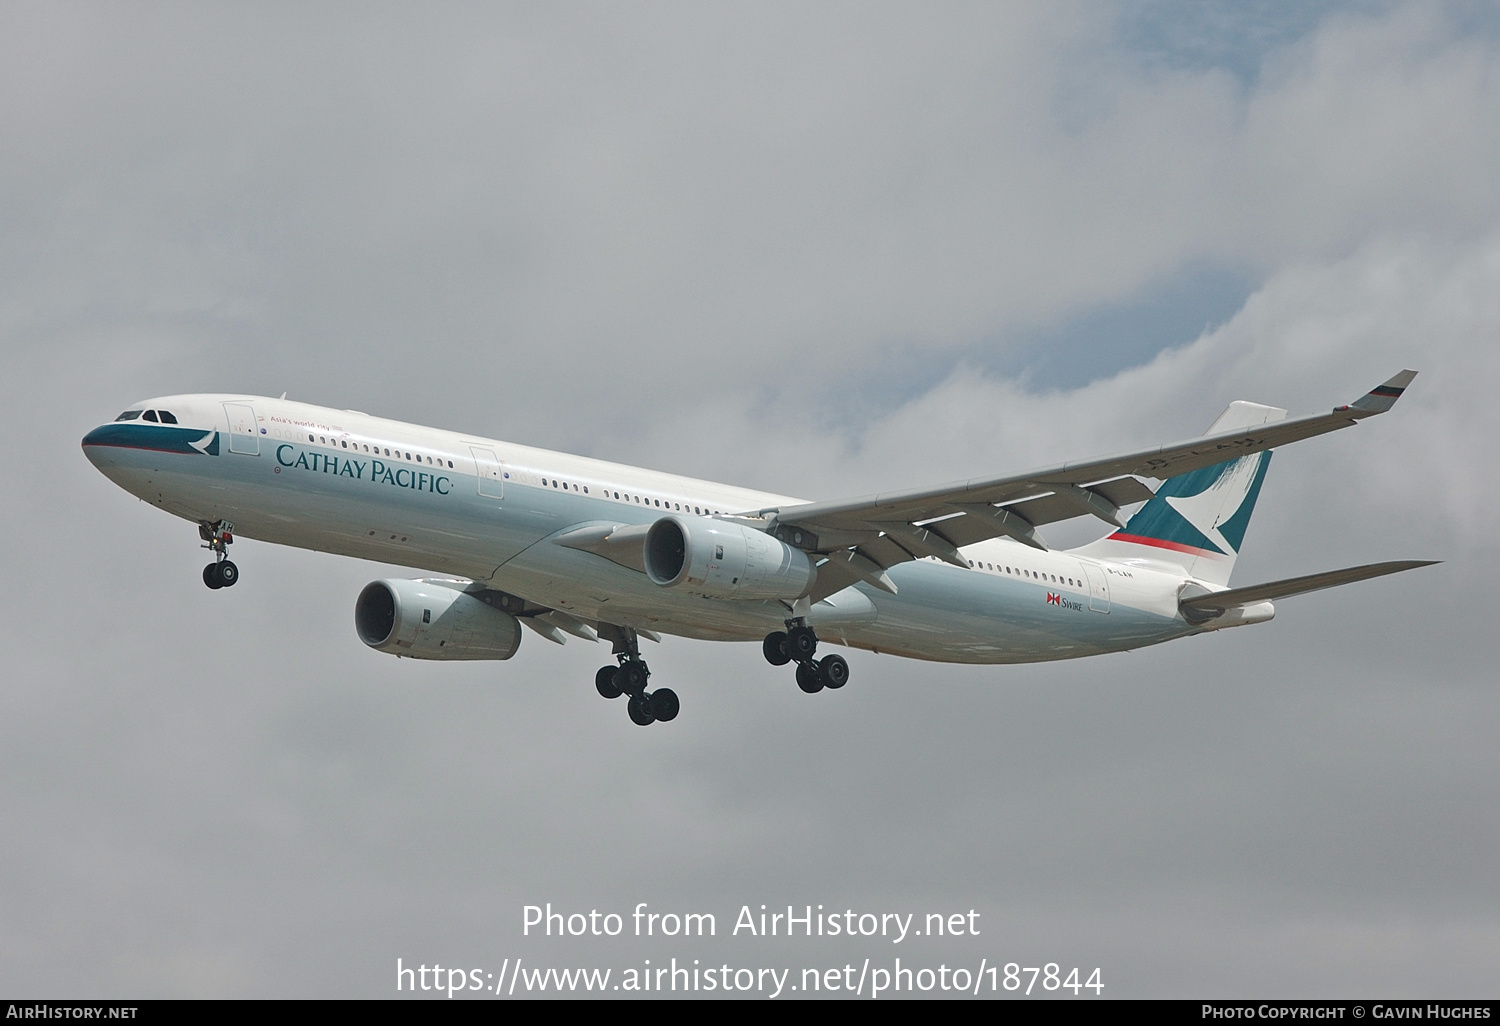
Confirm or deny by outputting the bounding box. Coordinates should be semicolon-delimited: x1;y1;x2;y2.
84;395;1224;663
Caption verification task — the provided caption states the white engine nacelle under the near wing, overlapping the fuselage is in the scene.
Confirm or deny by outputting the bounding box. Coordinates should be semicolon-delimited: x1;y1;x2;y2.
642;516;813;599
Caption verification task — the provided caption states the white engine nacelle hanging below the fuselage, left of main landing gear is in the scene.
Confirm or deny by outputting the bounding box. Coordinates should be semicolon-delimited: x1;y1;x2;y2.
354;581;521;659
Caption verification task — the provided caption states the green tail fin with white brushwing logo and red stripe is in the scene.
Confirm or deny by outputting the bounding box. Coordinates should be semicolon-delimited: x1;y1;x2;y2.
1080;402;1287;585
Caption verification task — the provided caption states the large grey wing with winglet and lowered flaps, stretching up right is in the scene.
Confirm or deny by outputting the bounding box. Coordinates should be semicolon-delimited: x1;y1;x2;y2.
756;371;1416;602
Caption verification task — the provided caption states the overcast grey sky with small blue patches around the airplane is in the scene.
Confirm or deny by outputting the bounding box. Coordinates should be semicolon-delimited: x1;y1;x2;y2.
0;0;1500;998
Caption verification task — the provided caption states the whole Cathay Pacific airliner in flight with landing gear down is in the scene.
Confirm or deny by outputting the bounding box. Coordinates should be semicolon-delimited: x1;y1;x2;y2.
83;371;1433;726
